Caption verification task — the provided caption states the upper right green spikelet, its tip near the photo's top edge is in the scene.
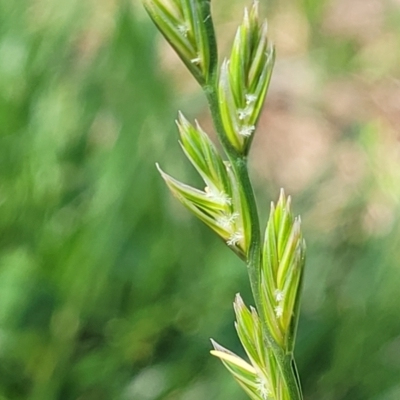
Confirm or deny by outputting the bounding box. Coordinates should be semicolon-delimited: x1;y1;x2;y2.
218;3;275;154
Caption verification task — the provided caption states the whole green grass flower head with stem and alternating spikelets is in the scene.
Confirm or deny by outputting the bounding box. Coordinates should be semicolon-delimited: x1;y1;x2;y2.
144;0;305;400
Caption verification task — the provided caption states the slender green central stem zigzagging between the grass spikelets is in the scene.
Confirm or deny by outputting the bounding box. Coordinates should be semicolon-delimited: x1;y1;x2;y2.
203;84;303;400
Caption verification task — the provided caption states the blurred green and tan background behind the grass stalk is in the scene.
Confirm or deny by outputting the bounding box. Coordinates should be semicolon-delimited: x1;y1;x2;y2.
0;0;400;400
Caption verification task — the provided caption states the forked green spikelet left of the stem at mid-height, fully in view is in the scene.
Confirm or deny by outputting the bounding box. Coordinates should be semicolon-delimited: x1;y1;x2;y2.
157;113;248;259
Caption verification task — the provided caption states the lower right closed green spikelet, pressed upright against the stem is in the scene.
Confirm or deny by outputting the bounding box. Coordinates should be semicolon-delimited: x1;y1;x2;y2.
261;190;305;352
